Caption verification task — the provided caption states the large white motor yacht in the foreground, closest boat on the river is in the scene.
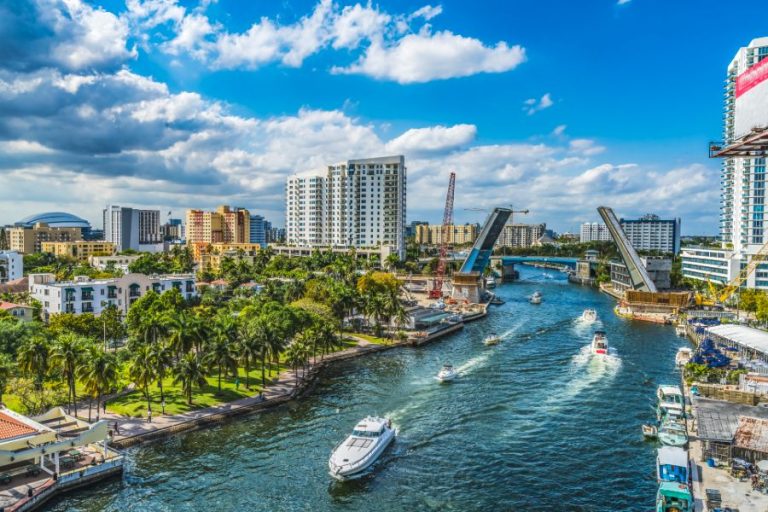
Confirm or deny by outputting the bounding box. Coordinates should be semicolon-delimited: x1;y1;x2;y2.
328;416;395;480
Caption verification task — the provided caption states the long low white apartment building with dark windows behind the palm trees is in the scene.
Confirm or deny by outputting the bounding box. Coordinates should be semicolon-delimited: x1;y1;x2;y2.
29;274;197;317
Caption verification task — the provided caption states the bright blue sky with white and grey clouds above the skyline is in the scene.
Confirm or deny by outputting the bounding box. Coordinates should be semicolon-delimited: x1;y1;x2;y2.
0;0;768;234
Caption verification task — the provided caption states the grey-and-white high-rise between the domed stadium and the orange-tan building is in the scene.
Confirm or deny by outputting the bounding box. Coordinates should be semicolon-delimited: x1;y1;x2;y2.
103;205;163;252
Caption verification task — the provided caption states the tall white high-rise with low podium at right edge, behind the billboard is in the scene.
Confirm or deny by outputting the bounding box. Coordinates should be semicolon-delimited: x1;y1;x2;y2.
683;37;768;289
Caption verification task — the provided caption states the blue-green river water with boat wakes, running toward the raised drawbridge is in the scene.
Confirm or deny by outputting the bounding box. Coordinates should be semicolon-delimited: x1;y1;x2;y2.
49;266;685;512
